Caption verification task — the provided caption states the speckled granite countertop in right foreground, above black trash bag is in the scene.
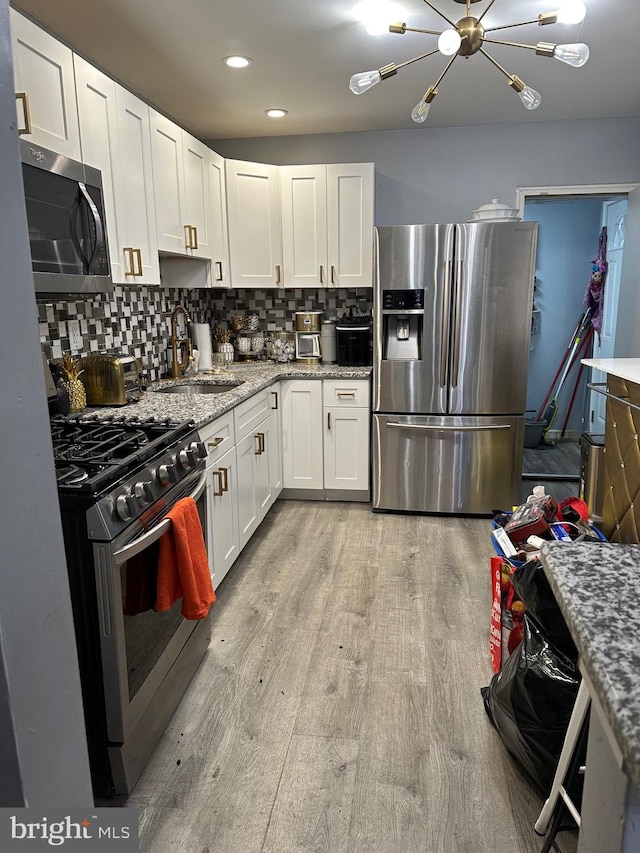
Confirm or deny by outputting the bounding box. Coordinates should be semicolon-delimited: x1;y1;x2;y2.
541;542;640;789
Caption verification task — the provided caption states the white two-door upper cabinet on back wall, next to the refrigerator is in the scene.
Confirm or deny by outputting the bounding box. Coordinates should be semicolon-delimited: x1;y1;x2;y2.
280;163;375;287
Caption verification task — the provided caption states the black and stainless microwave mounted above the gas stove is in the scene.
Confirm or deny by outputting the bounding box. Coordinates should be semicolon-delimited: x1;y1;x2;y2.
20;139;113;294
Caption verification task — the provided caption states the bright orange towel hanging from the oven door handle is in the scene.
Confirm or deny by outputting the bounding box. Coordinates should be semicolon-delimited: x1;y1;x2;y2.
156;498;216;619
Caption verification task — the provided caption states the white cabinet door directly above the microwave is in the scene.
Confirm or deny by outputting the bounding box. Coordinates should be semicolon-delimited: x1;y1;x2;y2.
9;9;82;160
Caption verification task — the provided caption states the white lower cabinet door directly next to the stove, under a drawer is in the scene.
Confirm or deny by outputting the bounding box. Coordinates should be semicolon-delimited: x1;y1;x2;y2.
207;447;240;589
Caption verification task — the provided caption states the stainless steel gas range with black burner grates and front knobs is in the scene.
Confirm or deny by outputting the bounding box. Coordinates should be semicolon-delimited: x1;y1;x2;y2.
51;416;210;797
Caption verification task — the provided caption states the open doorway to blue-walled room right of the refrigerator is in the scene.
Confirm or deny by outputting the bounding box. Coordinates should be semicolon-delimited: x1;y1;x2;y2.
518;185;634;501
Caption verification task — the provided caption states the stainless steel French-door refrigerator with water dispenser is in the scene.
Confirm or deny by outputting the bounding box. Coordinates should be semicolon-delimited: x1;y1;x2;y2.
372;222;537;515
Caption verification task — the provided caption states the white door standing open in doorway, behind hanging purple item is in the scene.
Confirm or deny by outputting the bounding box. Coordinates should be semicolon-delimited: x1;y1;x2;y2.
588;198;627;435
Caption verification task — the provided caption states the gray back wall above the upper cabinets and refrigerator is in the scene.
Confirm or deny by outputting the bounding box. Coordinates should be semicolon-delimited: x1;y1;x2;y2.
208;118;640;230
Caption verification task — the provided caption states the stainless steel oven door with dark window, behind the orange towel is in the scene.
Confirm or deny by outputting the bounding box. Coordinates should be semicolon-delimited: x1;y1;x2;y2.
93;462;207;743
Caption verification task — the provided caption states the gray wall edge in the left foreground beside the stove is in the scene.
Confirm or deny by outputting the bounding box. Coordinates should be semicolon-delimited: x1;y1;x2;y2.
0;0;93;804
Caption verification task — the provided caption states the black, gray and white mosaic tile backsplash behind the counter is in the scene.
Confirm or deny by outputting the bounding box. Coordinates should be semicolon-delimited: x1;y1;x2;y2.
38;286;373;382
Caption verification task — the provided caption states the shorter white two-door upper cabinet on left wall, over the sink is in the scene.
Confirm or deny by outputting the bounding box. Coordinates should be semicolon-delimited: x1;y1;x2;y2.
150;109;211;258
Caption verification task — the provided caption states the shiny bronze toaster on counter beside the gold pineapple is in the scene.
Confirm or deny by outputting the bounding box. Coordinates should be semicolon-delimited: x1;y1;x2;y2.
80;355;142;406
